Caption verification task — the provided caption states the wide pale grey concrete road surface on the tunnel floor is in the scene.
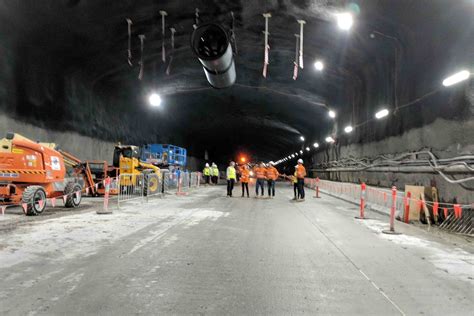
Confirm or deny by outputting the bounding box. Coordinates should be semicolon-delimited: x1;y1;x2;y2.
0;184;474;315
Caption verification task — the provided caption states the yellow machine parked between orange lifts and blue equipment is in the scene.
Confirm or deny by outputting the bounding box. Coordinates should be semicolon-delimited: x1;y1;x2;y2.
113;144;161;195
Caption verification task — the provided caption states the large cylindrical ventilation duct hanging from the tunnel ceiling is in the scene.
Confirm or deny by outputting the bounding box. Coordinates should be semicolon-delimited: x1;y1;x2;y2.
191;23;236;89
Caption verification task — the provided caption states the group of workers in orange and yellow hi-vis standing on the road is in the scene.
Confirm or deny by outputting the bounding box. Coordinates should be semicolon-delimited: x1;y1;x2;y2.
203;159;306;201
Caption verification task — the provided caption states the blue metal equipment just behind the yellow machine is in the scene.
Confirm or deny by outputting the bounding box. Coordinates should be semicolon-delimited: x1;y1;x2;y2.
140;144;187;167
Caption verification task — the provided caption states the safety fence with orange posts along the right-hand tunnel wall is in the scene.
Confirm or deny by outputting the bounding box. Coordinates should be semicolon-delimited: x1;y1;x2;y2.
305;178;474;235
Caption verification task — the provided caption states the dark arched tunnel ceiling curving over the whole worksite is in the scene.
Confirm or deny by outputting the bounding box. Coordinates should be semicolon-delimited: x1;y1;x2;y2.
0;0;474;200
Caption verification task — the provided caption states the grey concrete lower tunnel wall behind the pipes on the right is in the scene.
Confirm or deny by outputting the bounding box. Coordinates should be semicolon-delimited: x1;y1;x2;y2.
312;115;474;203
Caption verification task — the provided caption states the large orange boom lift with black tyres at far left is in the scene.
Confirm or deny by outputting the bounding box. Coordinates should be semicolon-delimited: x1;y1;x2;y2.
0;133;82;215
